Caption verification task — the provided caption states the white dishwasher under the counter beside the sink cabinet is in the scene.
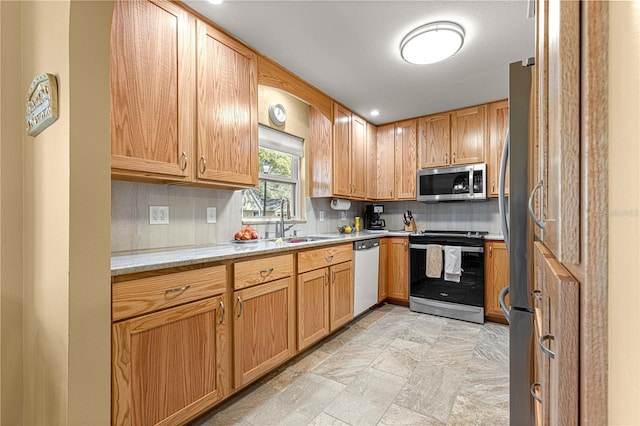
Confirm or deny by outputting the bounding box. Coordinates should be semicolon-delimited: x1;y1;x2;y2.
353;238;380;317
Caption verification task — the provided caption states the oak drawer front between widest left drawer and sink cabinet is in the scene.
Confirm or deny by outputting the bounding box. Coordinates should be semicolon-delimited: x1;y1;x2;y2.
233;254;293;290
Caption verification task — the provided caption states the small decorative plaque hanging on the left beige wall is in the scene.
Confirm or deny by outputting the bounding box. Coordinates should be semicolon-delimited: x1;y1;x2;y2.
26;74;58;136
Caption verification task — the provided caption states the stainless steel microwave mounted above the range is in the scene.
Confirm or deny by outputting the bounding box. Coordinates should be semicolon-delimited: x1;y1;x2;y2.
417;163;487;203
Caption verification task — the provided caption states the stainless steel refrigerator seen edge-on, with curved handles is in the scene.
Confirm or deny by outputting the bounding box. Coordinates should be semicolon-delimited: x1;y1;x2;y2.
499;58;535;425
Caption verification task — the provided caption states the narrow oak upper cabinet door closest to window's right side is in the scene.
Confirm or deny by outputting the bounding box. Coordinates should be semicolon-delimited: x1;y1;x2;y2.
333;104;351;197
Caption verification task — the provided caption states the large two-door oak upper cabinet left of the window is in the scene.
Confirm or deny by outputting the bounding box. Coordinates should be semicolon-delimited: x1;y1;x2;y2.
110;0;258;188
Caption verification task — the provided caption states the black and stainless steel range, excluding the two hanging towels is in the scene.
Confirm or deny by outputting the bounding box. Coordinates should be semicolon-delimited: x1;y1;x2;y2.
409;231;487;324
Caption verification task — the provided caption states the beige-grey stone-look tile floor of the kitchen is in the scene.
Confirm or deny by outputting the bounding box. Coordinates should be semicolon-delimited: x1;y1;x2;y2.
193;305;509;426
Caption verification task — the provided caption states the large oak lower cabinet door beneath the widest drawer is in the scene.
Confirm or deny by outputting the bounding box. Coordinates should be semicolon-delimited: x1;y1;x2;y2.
111;296;231;425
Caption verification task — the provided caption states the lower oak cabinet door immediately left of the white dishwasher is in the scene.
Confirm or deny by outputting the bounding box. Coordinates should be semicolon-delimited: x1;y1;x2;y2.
329;262;353;331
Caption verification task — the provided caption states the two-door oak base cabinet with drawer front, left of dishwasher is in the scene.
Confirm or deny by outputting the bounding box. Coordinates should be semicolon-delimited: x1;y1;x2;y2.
298;244;353;351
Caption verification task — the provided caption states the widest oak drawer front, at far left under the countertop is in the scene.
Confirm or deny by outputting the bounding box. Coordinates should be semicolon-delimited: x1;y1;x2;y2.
111;265;227;321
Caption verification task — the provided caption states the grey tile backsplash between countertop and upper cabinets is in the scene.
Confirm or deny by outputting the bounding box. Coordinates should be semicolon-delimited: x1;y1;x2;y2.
111;180;501;252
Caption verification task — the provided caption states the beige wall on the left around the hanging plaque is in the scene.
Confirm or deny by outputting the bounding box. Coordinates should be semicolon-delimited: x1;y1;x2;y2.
0;0;112;425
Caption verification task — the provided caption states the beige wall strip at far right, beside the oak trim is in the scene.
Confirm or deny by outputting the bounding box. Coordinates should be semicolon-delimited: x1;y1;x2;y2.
608;0;640;425
